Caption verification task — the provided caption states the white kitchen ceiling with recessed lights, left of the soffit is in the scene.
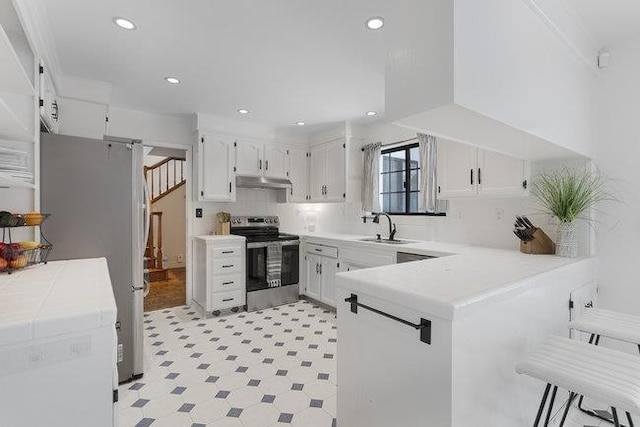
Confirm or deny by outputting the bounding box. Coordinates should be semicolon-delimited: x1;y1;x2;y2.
43;0;385;127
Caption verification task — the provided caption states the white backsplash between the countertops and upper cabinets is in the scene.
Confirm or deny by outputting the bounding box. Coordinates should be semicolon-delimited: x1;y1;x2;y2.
193;188;590;254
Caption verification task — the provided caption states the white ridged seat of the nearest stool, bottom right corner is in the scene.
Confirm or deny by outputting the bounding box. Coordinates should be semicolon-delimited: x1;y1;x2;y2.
516;336;640;415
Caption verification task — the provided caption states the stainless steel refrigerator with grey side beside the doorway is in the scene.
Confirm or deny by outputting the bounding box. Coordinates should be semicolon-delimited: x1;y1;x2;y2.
40;133;146;382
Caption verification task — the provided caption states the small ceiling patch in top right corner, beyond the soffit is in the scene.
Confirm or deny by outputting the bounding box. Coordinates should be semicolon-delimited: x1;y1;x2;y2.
564;0;640;47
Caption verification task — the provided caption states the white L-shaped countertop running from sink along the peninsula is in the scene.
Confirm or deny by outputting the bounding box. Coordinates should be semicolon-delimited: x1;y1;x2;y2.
304;233;591;319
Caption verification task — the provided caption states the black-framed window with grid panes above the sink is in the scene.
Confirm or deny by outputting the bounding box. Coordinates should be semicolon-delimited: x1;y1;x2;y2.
380;144;421;215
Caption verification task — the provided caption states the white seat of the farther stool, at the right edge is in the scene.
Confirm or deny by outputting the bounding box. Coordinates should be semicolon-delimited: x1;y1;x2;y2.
569;308;640;344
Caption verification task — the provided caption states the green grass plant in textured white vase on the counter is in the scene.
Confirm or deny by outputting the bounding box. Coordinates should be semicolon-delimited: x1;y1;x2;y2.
533;168;612;258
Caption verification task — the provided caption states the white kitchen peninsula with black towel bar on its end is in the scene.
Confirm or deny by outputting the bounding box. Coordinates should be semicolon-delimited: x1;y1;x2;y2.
336;242;595;427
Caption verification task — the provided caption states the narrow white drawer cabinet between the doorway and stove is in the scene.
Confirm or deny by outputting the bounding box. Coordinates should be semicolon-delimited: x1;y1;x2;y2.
193;236;246;313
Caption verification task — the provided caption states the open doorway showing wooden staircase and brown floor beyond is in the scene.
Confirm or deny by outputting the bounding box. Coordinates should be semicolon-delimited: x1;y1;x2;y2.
143;145;188;312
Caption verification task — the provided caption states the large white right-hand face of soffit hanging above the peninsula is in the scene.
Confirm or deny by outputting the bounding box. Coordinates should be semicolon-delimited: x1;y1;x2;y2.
455;0;597;155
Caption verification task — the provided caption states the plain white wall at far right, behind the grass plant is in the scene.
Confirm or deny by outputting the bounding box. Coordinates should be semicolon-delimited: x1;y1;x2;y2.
595;39;640;315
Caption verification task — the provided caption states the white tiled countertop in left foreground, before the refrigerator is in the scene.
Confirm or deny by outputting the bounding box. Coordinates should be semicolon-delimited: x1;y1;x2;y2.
0;258;117;345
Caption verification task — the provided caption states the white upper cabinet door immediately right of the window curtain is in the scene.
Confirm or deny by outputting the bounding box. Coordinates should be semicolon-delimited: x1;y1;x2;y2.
437;141;478;200
